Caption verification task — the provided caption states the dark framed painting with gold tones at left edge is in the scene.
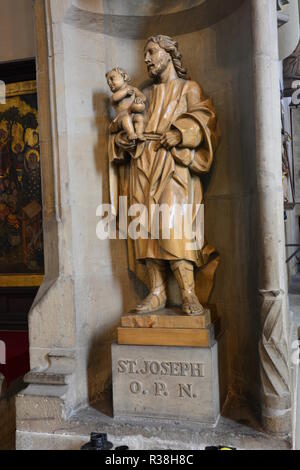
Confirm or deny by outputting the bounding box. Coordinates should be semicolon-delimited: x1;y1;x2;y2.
0;80;44;287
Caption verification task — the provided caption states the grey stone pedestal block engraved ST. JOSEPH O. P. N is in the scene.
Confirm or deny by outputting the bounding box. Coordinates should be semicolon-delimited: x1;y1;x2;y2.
112;342;220;425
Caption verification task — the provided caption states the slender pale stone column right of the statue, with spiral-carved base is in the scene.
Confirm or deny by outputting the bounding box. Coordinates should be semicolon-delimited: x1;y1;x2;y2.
251;0;291;433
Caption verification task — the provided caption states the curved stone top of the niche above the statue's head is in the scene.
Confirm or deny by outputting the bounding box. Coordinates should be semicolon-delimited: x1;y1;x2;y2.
65;0;245;39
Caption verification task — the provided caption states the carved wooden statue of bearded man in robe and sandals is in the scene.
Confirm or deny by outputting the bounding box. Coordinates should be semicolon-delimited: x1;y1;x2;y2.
109;35;218;315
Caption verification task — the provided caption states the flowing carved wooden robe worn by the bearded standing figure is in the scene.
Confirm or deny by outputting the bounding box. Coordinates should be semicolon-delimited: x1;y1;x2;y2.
109;78;218;298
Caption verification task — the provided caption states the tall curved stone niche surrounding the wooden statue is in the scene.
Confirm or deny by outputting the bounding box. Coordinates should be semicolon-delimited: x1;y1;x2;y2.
17;0;292;448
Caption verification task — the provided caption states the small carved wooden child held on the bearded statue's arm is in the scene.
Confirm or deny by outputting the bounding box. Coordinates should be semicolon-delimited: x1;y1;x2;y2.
106;67;146;140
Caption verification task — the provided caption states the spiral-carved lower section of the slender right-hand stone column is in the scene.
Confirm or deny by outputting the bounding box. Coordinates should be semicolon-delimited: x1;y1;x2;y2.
259;290;291;433
